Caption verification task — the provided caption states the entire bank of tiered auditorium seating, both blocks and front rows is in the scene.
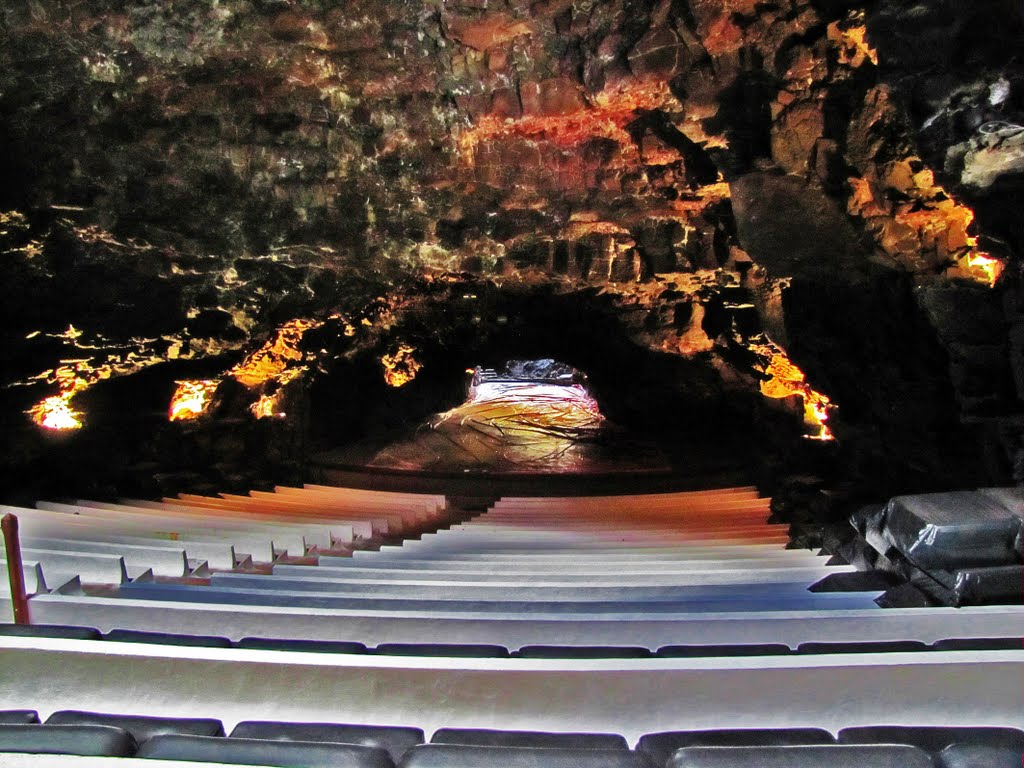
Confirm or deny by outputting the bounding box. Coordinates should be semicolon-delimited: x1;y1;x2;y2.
0;486;1024;768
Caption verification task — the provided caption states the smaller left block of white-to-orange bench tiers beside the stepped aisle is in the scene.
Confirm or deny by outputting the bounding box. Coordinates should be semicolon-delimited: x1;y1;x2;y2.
0;487;450;600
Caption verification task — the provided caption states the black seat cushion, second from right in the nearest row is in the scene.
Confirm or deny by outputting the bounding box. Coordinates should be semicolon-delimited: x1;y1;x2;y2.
666;744;933;768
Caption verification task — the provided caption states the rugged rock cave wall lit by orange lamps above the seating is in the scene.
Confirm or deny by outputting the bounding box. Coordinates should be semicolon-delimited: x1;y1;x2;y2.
0;0;1024;495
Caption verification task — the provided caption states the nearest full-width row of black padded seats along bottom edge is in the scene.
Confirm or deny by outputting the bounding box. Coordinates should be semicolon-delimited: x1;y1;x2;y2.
0;711;1024;768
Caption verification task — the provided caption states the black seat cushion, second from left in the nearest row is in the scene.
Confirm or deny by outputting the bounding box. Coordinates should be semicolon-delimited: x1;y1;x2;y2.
138;735;394;768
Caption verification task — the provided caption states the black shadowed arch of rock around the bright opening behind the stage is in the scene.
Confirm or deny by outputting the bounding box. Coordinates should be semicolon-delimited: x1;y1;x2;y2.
301;283;782;481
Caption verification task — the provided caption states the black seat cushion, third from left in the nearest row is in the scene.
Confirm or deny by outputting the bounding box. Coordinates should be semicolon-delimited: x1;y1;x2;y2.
398;744;655;768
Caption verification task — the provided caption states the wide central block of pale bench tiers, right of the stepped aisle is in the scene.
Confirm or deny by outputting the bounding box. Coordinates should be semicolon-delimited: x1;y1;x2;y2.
14;488;1024;651
